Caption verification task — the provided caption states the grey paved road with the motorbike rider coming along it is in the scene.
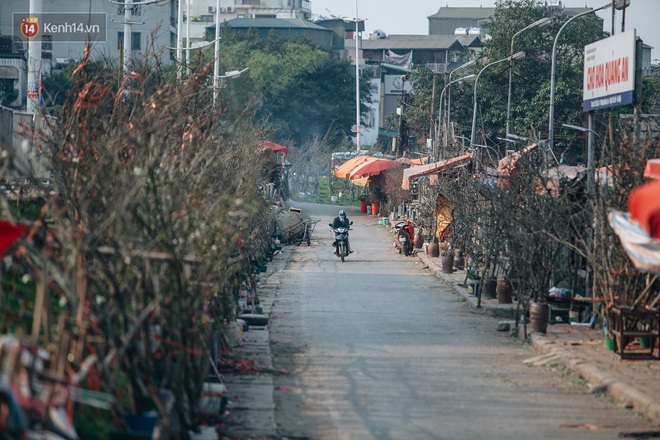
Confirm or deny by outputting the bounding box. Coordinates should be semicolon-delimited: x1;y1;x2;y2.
269;204;654;440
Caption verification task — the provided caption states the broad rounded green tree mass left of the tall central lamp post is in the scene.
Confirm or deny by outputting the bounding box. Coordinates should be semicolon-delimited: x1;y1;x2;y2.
209;28;370;145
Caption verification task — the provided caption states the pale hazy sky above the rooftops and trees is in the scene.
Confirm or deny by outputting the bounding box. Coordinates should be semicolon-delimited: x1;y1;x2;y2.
311;0;660;64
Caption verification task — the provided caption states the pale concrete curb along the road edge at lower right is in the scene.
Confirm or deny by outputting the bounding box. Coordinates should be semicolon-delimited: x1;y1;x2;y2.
530;328;660;423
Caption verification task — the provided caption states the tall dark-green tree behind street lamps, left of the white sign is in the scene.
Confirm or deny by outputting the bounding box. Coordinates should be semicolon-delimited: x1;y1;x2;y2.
478;0;606;156
